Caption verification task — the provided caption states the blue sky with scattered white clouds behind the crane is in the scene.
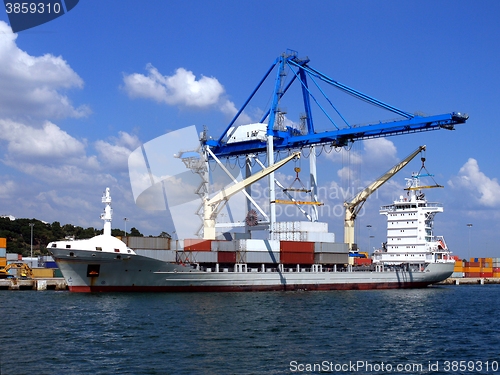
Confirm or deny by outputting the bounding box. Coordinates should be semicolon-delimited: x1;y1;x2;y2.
0;0;500;257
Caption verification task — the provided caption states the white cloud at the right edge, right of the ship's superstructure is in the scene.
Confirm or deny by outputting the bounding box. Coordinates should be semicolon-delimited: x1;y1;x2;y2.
448;158;500;207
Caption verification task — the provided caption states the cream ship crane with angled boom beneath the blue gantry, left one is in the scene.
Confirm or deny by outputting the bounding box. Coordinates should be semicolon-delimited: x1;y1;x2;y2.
203;152;300;240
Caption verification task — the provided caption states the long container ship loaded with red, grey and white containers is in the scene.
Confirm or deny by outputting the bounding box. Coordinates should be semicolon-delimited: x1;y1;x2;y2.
48;175;455;292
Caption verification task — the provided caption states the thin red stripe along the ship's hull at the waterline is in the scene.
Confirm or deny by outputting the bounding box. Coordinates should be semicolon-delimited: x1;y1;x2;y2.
69;282;430;293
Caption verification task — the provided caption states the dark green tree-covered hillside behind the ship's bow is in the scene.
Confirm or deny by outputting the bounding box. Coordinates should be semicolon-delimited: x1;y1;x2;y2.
0;217;144;256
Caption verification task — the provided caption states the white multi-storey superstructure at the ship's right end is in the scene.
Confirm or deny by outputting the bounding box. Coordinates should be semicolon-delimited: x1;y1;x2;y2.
373;174;454;265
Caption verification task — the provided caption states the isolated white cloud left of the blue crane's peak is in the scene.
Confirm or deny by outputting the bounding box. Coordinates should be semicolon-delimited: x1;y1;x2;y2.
123;64;224;108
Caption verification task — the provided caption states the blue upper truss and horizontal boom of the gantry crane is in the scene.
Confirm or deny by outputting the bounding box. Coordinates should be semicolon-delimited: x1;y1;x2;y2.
202;51;469;157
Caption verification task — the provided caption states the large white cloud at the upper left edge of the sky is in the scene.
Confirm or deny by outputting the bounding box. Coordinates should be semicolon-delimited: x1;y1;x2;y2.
0;21;90;119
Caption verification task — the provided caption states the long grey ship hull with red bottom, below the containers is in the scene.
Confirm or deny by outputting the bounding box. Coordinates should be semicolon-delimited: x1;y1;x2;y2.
51;248;454;292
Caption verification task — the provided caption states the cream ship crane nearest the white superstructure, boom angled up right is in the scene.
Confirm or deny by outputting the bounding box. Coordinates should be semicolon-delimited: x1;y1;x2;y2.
344;145;425;250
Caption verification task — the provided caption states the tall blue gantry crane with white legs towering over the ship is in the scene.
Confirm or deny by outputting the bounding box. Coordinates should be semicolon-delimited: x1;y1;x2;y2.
201;50;468;237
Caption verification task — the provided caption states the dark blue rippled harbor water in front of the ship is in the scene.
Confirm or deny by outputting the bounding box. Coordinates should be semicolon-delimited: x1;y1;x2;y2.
0;285;500;375
